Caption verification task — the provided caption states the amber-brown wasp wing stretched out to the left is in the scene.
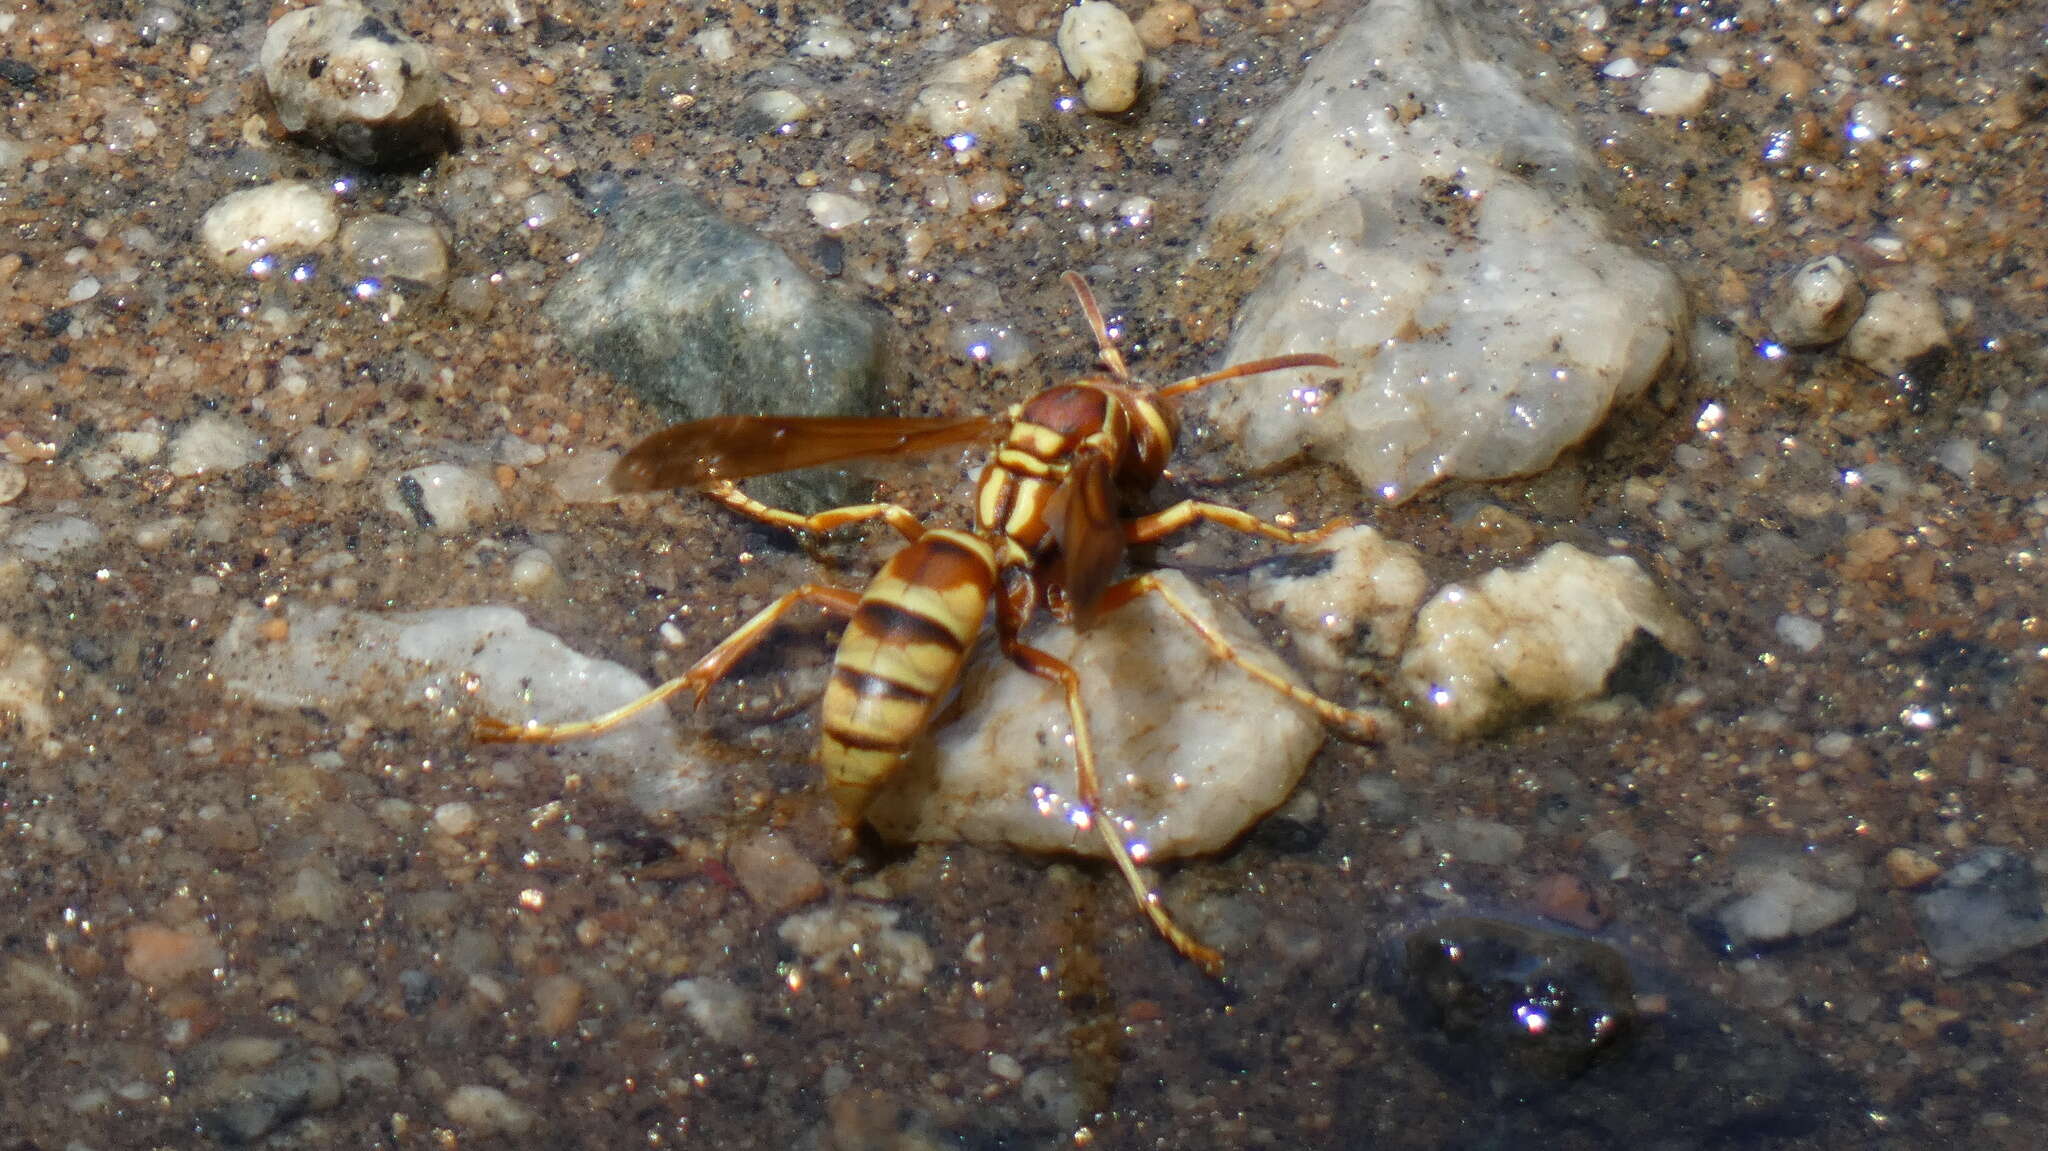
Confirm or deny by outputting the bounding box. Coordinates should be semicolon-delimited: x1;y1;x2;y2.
612;416;995;492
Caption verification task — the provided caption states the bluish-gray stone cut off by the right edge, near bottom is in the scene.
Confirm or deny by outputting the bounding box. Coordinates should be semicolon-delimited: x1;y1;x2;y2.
1913;848;2048;977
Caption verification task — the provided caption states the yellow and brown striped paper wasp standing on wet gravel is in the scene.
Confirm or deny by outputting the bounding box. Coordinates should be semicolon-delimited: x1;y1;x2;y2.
477;272;1380;975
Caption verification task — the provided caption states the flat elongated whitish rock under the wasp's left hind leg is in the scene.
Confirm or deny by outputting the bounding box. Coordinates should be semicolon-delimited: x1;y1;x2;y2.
213;604;713;811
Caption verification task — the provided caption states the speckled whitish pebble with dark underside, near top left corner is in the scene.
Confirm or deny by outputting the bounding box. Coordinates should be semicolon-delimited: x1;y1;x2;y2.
258;0;453;168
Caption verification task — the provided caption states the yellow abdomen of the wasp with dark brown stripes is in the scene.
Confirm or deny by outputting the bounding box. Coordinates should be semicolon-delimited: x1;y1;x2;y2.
819;530;995;827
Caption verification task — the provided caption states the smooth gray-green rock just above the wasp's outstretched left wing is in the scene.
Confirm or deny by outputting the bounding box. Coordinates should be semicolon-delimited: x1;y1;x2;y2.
545;190;881;428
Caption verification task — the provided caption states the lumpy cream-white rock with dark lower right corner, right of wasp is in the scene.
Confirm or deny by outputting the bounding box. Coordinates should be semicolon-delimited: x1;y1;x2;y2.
1399;543;1696;735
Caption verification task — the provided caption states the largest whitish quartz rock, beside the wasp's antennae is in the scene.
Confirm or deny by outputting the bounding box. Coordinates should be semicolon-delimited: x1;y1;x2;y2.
1210;0;1690;500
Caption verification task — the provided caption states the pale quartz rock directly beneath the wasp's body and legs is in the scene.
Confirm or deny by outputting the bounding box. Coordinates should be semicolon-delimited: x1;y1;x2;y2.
868;571;1323;858
